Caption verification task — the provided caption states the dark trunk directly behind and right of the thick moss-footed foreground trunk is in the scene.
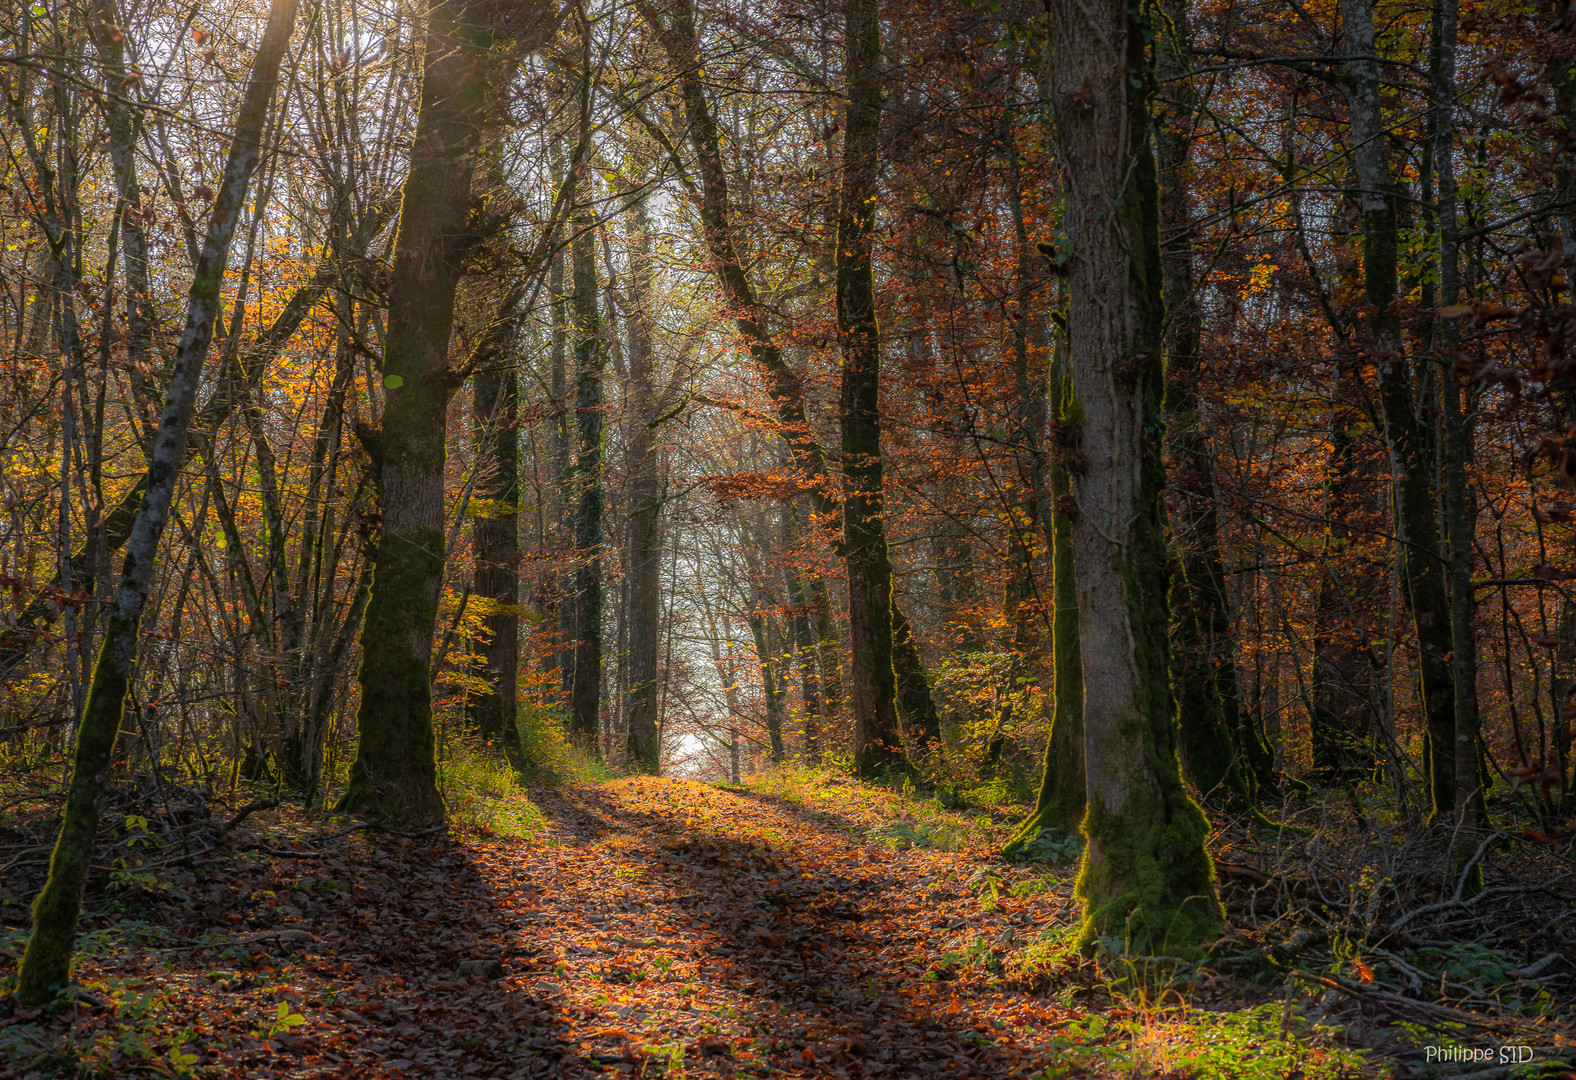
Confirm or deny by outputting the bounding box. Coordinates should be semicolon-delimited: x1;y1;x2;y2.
1155;6;1269;804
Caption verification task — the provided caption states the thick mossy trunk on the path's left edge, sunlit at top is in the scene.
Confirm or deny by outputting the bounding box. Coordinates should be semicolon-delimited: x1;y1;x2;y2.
339;0;493;821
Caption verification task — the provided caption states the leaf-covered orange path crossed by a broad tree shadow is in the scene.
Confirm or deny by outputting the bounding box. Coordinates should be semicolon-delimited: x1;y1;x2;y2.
482;777;1070;1077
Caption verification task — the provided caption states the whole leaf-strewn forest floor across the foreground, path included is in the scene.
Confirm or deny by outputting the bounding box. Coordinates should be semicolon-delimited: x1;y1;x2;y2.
0;774;1569;1080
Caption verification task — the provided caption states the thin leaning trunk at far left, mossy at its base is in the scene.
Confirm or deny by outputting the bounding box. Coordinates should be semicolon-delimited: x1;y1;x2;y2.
16;0;298;1007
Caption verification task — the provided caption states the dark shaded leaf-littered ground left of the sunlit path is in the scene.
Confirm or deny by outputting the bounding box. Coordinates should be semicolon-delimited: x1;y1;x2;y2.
0;812;600;1080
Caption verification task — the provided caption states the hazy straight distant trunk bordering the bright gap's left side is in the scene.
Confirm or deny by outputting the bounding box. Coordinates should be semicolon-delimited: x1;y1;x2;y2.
624;196;663;774
